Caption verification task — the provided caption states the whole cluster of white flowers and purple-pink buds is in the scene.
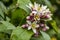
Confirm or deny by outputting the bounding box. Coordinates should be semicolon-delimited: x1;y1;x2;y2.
22;3;52;34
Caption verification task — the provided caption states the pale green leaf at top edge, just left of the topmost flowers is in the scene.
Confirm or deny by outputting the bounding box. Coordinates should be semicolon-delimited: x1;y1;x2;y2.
17;0;31;13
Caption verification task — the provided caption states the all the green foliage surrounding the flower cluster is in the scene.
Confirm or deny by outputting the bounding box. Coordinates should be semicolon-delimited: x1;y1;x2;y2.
0;0;60;40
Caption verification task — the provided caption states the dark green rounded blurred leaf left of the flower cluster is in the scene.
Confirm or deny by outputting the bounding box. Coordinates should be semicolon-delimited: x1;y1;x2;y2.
11;9;27;25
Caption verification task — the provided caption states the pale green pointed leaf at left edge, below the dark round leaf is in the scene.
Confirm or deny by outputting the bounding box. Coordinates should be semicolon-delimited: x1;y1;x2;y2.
0;21;15;31
